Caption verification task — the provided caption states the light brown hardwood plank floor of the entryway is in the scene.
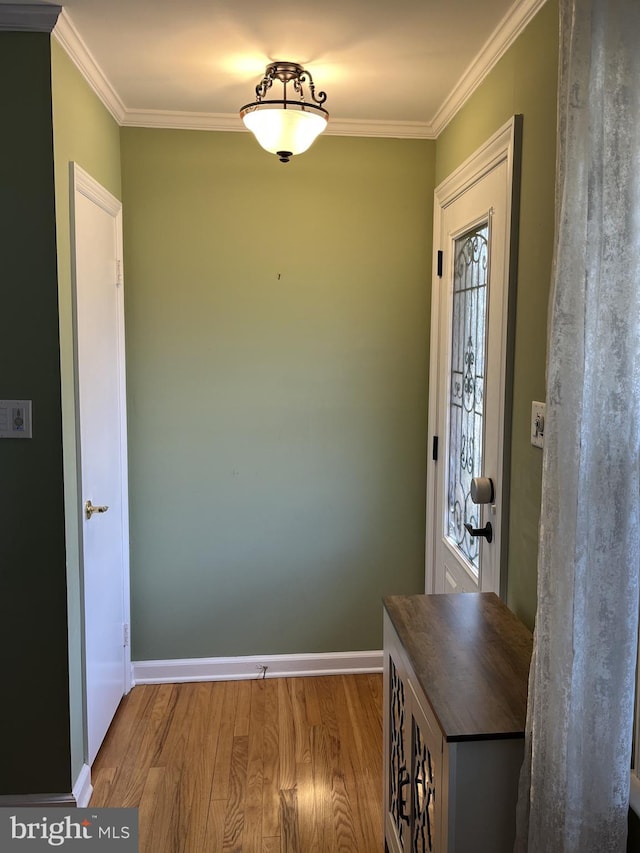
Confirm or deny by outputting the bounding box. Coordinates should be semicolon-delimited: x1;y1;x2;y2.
91;675;383;853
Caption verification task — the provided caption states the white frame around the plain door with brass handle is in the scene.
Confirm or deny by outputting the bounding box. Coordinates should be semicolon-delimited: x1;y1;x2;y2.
69;162;132;752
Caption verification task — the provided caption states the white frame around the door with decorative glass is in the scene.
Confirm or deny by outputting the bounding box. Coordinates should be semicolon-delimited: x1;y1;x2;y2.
425;115;522;599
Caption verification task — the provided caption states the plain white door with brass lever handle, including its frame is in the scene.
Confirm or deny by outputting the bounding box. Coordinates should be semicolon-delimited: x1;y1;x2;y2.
72;164;130;765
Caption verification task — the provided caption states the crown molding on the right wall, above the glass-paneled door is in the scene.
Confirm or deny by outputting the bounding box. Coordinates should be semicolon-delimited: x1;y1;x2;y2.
431;0;547;137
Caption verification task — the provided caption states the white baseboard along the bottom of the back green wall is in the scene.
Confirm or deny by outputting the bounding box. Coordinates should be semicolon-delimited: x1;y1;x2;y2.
132;651;382;684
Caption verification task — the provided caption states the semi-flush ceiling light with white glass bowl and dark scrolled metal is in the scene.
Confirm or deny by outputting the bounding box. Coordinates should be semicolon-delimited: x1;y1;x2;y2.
240;62;329;163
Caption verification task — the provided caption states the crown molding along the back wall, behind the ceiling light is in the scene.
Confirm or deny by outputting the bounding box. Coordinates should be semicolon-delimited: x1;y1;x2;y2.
120;110;435;139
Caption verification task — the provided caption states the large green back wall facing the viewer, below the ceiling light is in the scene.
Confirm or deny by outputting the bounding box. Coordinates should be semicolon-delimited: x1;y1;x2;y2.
122;128;435;660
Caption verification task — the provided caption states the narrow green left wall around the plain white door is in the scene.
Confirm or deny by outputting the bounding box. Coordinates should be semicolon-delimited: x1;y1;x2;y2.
51;39;120;780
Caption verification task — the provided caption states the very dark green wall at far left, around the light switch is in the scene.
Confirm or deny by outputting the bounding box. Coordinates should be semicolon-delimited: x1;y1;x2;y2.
0;33;71;794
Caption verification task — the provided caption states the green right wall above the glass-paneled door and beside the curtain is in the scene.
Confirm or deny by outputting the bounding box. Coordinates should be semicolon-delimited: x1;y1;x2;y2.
436;0;558;626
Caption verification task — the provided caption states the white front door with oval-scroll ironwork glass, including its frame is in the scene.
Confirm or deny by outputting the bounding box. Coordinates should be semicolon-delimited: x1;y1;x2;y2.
426;119;519;593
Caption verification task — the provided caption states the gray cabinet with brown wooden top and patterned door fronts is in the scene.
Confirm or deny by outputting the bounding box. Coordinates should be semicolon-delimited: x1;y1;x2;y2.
384;593;531;853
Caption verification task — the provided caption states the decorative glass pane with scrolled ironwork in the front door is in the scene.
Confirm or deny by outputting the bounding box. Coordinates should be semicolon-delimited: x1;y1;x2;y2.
445;222;489;575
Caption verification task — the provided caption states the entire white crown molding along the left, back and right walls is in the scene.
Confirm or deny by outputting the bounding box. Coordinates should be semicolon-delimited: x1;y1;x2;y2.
52;0;547;139
